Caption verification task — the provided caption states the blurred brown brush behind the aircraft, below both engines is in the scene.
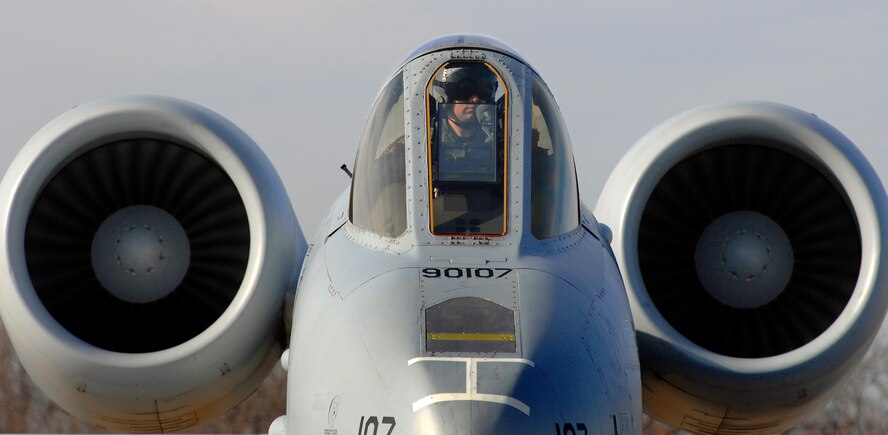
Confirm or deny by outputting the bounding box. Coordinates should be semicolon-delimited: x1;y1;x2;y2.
0;318;888;435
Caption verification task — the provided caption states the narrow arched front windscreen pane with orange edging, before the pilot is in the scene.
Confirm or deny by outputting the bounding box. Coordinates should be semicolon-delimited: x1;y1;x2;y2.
427;62;508;236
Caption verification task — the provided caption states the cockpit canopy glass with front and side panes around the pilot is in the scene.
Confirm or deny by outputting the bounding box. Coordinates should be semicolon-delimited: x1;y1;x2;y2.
350;36;579;240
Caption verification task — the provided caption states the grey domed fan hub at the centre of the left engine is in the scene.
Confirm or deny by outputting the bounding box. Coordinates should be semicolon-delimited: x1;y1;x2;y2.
92;205;191;303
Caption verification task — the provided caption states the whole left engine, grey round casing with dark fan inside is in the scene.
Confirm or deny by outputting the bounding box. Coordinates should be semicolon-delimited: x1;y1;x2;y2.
0;97;306;432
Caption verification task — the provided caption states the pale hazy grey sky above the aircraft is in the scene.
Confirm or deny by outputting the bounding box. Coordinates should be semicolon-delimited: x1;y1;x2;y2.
0;0;888;237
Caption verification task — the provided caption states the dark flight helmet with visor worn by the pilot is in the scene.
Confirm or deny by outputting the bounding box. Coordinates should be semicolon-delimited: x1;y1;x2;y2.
433;62;499;103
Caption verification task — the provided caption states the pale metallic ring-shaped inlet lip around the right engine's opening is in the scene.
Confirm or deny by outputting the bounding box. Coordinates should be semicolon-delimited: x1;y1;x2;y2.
608;101;888;374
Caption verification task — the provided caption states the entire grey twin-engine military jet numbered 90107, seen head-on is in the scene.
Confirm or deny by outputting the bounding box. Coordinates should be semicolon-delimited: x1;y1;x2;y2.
0;35;888;435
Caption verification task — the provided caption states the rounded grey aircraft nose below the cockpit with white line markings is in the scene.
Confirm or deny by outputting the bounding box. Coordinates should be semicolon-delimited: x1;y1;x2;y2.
287;218;641;433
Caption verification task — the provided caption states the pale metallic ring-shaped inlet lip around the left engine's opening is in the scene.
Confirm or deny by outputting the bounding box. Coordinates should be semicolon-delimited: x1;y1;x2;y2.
0;96;292;367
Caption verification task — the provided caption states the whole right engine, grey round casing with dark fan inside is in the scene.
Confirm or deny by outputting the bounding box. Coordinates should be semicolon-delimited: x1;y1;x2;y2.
595;103;888;433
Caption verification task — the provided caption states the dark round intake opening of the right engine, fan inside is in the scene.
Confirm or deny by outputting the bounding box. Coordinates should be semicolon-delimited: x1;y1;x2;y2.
638;142;860;358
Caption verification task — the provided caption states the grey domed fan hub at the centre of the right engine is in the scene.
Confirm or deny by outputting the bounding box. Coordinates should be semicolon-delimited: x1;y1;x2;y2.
694;211;793;308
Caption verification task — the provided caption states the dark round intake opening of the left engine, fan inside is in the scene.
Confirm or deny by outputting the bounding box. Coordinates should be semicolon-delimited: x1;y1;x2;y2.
25;139;250;353
